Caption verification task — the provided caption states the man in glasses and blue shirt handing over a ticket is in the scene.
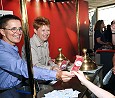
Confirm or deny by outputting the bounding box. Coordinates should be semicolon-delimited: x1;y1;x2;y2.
0;15;74;98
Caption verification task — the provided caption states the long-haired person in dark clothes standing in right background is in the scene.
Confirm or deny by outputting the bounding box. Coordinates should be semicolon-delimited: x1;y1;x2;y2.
94;20;109;51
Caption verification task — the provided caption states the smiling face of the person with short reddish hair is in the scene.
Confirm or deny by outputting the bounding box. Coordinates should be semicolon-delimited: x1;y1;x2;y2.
34;25;50;42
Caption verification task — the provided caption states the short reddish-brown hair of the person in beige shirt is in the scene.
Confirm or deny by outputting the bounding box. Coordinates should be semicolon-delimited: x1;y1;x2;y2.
33;17;50;30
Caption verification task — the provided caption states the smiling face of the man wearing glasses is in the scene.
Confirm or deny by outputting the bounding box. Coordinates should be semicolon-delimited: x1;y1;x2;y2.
1;20;22;45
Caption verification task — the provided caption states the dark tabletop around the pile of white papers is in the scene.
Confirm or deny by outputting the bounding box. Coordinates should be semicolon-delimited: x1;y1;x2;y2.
37;67;102;98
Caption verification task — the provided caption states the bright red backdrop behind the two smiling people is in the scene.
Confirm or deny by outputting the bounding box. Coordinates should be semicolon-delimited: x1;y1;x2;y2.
0;0;89;62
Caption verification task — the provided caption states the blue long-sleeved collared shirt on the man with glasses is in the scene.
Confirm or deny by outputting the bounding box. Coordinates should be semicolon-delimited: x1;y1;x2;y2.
0;39;56;90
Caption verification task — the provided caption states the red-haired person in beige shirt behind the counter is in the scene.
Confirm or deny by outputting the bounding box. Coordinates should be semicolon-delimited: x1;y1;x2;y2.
22;17;59;70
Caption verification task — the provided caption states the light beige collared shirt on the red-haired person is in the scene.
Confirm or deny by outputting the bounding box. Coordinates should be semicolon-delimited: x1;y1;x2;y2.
22;34;56;69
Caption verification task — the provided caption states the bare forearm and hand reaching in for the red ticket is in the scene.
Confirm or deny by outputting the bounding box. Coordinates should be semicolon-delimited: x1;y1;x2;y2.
74;71;115;98
